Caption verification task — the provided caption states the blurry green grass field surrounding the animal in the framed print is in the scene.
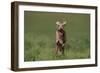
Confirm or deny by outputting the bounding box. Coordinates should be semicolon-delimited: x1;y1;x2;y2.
24;11;90;61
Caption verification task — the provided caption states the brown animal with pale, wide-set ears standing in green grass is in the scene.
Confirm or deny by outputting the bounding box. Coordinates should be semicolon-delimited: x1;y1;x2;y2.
56;21;66;54
